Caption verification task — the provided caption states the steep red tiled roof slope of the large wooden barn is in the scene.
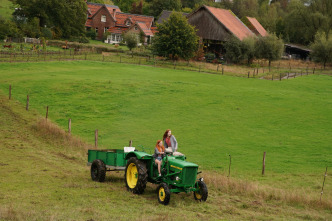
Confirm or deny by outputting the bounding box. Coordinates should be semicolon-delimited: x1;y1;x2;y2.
203;6;254;40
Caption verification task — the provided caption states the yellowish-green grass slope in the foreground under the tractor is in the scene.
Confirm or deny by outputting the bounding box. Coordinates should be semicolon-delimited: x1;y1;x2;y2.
0;96;332;220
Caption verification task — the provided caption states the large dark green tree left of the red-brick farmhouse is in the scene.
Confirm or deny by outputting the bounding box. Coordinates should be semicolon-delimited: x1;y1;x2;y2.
11;0;87;38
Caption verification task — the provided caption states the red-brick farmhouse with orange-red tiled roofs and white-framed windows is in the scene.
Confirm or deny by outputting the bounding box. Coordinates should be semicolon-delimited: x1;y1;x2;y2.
85;2;155;44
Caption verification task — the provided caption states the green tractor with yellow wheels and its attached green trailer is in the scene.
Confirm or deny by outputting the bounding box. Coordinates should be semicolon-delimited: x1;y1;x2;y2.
88;147;208;205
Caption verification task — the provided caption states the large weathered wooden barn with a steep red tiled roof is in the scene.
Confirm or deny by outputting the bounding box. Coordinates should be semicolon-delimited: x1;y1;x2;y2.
187;5;258;54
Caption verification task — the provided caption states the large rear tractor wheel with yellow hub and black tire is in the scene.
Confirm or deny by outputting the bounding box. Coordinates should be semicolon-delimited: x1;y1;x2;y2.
125;157;148;194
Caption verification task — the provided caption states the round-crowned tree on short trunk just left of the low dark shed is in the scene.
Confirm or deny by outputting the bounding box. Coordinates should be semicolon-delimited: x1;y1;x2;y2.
255;34;284;67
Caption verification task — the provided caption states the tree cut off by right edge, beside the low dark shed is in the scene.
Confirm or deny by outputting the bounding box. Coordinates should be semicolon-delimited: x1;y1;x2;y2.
311;32;332;69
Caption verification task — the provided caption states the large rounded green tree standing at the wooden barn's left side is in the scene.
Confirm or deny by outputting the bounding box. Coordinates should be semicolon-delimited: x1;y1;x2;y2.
152;12;199;60
